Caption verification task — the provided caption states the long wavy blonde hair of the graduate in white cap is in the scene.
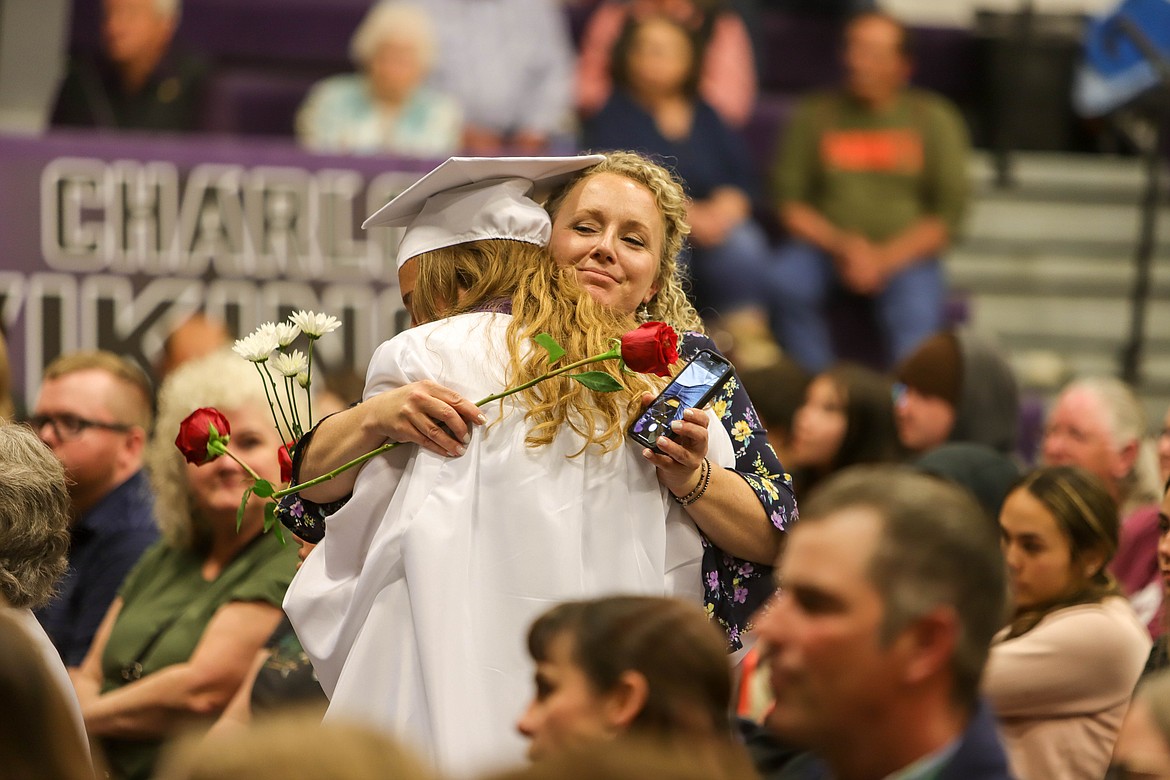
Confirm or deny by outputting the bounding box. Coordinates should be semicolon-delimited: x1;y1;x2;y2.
411;239;662;454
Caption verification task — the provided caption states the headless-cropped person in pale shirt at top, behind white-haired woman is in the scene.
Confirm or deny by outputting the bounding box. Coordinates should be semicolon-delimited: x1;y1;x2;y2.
420;0;573;156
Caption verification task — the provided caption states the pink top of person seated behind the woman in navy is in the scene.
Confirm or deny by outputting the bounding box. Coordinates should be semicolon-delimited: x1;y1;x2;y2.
577;1;757;127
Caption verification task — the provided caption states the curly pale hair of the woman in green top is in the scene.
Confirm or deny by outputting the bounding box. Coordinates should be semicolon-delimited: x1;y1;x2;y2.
146;350;304;548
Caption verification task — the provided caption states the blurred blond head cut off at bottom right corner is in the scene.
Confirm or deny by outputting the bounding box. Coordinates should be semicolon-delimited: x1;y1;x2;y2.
1106;672;1170;780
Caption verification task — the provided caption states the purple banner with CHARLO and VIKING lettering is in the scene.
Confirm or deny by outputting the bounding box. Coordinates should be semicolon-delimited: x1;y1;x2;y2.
0;133;435;403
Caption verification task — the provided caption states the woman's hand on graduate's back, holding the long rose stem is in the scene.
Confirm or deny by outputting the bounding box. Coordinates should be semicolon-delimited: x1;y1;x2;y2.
365;379;487;457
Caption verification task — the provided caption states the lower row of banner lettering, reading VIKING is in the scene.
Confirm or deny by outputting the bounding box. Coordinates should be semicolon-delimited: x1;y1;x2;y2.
0;272;408;411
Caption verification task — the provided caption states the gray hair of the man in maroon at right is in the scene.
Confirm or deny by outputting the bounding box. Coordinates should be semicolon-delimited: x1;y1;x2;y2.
1061;377;1162;515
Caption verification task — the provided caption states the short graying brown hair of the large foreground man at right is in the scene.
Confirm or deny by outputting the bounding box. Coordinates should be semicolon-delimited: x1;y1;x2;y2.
800;465;1007;707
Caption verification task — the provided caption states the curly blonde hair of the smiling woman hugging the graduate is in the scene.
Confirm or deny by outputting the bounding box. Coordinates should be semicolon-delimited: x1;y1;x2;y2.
544;152;704;333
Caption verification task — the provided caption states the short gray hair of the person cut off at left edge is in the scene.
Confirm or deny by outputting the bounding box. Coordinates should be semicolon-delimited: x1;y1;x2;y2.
0;423;69;609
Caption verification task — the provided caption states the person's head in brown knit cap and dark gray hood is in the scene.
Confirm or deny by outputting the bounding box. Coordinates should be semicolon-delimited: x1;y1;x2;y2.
894;329;1019;455
